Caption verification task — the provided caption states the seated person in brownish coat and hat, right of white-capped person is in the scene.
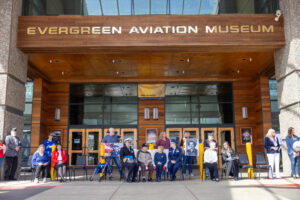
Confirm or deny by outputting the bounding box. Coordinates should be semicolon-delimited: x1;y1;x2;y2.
137;143;153;182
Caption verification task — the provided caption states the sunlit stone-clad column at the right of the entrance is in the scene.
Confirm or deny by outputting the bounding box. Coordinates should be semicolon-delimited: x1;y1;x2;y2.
275;0;300;176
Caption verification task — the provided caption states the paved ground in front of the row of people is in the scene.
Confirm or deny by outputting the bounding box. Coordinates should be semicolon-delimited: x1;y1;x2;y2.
0;178;300;200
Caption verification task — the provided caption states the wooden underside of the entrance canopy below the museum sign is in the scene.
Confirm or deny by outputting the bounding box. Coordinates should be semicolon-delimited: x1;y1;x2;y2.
28;52;274;82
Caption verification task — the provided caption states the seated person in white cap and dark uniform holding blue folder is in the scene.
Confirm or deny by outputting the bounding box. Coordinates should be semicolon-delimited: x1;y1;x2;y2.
120;138;139;183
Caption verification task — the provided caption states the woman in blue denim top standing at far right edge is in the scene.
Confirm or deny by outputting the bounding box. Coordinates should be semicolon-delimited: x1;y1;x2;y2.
285;127;300;178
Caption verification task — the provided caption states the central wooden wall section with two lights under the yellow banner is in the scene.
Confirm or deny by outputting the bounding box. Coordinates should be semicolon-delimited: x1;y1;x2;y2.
138;100;165;147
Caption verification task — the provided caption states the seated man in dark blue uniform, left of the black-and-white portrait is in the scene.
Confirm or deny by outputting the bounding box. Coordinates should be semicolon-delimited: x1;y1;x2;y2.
168;139;182;181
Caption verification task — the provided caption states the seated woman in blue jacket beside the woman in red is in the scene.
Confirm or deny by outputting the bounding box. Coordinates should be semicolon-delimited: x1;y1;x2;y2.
31;144;50;183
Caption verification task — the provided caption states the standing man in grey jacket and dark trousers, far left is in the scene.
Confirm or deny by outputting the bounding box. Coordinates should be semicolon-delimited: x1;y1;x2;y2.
4;128;21;180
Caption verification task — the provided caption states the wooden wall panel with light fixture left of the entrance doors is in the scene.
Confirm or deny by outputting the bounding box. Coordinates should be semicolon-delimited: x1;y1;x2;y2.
31;78;69;154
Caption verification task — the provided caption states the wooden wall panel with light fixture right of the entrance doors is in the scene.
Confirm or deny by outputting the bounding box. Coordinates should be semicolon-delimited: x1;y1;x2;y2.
233;77;271;163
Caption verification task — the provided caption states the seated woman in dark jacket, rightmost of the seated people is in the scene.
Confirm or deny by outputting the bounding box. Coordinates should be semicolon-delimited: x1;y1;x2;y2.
222;142;239;181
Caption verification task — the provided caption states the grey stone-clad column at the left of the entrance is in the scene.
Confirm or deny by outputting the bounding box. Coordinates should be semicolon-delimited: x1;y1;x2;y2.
0;0;27;176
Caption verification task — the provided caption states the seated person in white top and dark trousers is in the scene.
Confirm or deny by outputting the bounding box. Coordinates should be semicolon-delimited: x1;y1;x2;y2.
204;142;220;182
